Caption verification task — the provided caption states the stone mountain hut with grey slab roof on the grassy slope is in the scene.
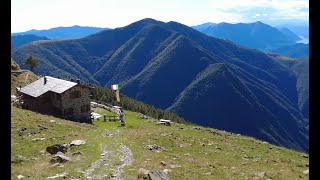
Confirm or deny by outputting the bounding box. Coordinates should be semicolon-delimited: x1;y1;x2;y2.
17;76;91;122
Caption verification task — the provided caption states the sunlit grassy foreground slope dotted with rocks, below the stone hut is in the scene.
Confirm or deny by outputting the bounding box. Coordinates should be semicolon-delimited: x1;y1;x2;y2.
11;106;309;179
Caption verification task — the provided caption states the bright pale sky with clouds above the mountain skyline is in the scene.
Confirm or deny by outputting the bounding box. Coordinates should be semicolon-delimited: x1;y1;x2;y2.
11;0;309;32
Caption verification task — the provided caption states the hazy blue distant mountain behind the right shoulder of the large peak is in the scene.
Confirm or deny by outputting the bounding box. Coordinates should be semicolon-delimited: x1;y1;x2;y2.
192;21;299;51
